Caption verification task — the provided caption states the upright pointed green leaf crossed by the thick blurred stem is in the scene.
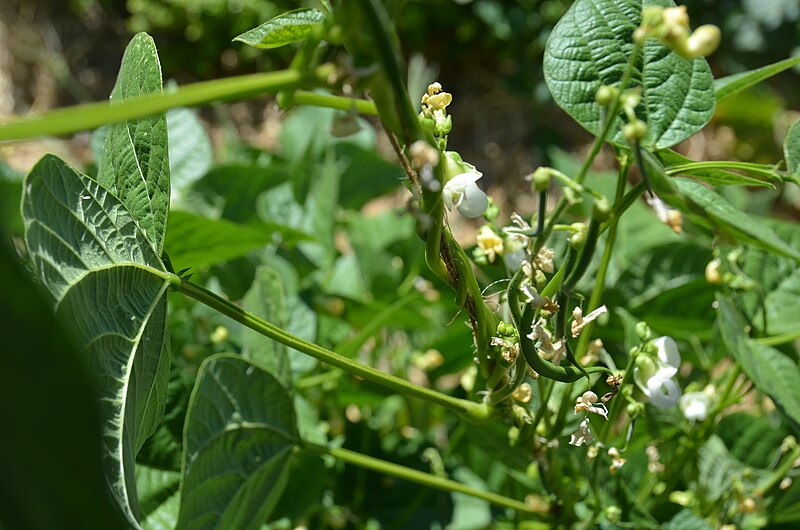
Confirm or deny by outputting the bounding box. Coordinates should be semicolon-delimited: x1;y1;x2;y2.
97;33;170;253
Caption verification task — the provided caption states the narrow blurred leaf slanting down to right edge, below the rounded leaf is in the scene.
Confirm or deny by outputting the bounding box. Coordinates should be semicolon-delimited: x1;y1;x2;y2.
674;178;800;262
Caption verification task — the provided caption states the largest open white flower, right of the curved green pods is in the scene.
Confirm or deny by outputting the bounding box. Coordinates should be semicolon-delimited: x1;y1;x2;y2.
633;337;681;408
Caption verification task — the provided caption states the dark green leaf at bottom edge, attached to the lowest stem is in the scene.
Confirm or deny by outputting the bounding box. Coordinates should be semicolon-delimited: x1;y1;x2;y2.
178;355;298;530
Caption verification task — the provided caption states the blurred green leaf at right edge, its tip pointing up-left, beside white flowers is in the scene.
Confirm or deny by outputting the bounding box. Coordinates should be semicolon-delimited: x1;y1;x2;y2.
717;295;800;427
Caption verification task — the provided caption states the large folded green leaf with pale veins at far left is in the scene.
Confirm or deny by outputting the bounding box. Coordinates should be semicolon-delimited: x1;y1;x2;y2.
22;155;176;525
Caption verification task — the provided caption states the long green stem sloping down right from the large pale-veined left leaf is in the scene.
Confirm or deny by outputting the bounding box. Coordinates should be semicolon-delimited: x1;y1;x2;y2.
178;281;494;421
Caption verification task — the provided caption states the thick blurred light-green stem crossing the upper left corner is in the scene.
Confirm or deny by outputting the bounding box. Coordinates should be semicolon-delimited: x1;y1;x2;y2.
0;64;334;141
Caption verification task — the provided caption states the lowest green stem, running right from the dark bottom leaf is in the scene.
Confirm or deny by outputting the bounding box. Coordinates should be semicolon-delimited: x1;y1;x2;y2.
301;441;541;515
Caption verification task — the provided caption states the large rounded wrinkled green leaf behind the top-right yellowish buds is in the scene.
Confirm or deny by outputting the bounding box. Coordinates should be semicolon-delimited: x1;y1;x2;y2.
544;0;714;149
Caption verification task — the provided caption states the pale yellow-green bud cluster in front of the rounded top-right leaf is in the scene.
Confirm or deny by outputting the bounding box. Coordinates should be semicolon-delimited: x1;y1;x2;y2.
633;6;721;59
